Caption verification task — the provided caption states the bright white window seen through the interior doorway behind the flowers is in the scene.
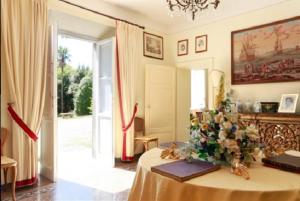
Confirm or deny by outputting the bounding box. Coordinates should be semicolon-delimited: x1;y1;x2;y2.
191;69;206;110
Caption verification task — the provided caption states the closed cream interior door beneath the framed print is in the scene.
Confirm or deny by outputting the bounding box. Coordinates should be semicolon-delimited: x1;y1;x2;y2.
145;65;176;142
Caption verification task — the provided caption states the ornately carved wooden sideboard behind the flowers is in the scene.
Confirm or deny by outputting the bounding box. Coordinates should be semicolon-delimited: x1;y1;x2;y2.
239;113;300;151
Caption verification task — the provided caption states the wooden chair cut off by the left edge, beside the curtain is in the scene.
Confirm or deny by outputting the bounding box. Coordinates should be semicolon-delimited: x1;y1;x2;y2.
1;128;17;201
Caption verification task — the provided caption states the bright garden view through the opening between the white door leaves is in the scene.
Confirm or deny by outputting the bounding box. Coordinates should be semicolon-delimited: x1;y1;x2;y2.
56;32;94;179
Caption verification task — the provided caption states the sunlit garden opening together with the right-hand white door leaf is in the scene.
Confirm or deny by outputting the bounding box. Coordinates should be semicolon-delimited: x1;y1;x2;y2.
57;34;114;179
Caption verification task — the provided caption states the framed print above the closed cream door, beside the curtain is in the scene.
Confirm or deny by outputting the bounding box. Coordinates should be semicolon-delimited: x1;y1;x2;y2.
144;32;164;59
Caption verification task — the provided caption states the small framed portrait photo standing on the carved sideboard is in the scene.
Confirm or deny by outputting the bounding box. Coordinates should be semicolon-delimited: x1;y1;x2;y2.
278;94;298;113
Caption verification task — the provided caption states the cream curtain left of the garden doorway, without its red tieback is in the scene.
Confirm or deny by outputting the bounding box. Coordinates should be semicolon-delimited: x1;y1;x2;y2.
1;0;48;186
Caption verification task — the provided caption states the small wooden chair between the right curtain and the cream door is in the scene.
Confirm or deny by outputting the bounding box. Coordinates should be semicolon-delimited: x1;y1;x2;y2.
134;117;158;151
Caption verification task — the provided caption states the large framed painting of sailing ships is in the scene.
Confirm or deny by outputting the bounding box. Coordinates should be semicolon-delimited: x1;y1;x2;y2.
231;16;300;84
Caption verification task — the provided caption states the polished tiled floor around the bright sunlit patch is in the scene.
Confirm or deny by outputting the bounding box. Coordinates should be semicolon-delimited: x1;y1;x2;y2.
1;160;137;201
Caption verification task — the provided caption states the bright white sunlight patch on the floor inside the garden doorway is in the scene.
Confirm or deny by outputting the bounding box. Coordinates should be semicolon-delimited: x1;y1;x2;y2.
58;152;135;193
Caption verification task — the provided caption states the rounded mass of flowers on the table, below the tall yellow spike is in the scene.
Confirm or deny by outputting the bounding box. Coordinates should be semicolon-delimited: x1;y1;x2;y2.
189;110;259;178
